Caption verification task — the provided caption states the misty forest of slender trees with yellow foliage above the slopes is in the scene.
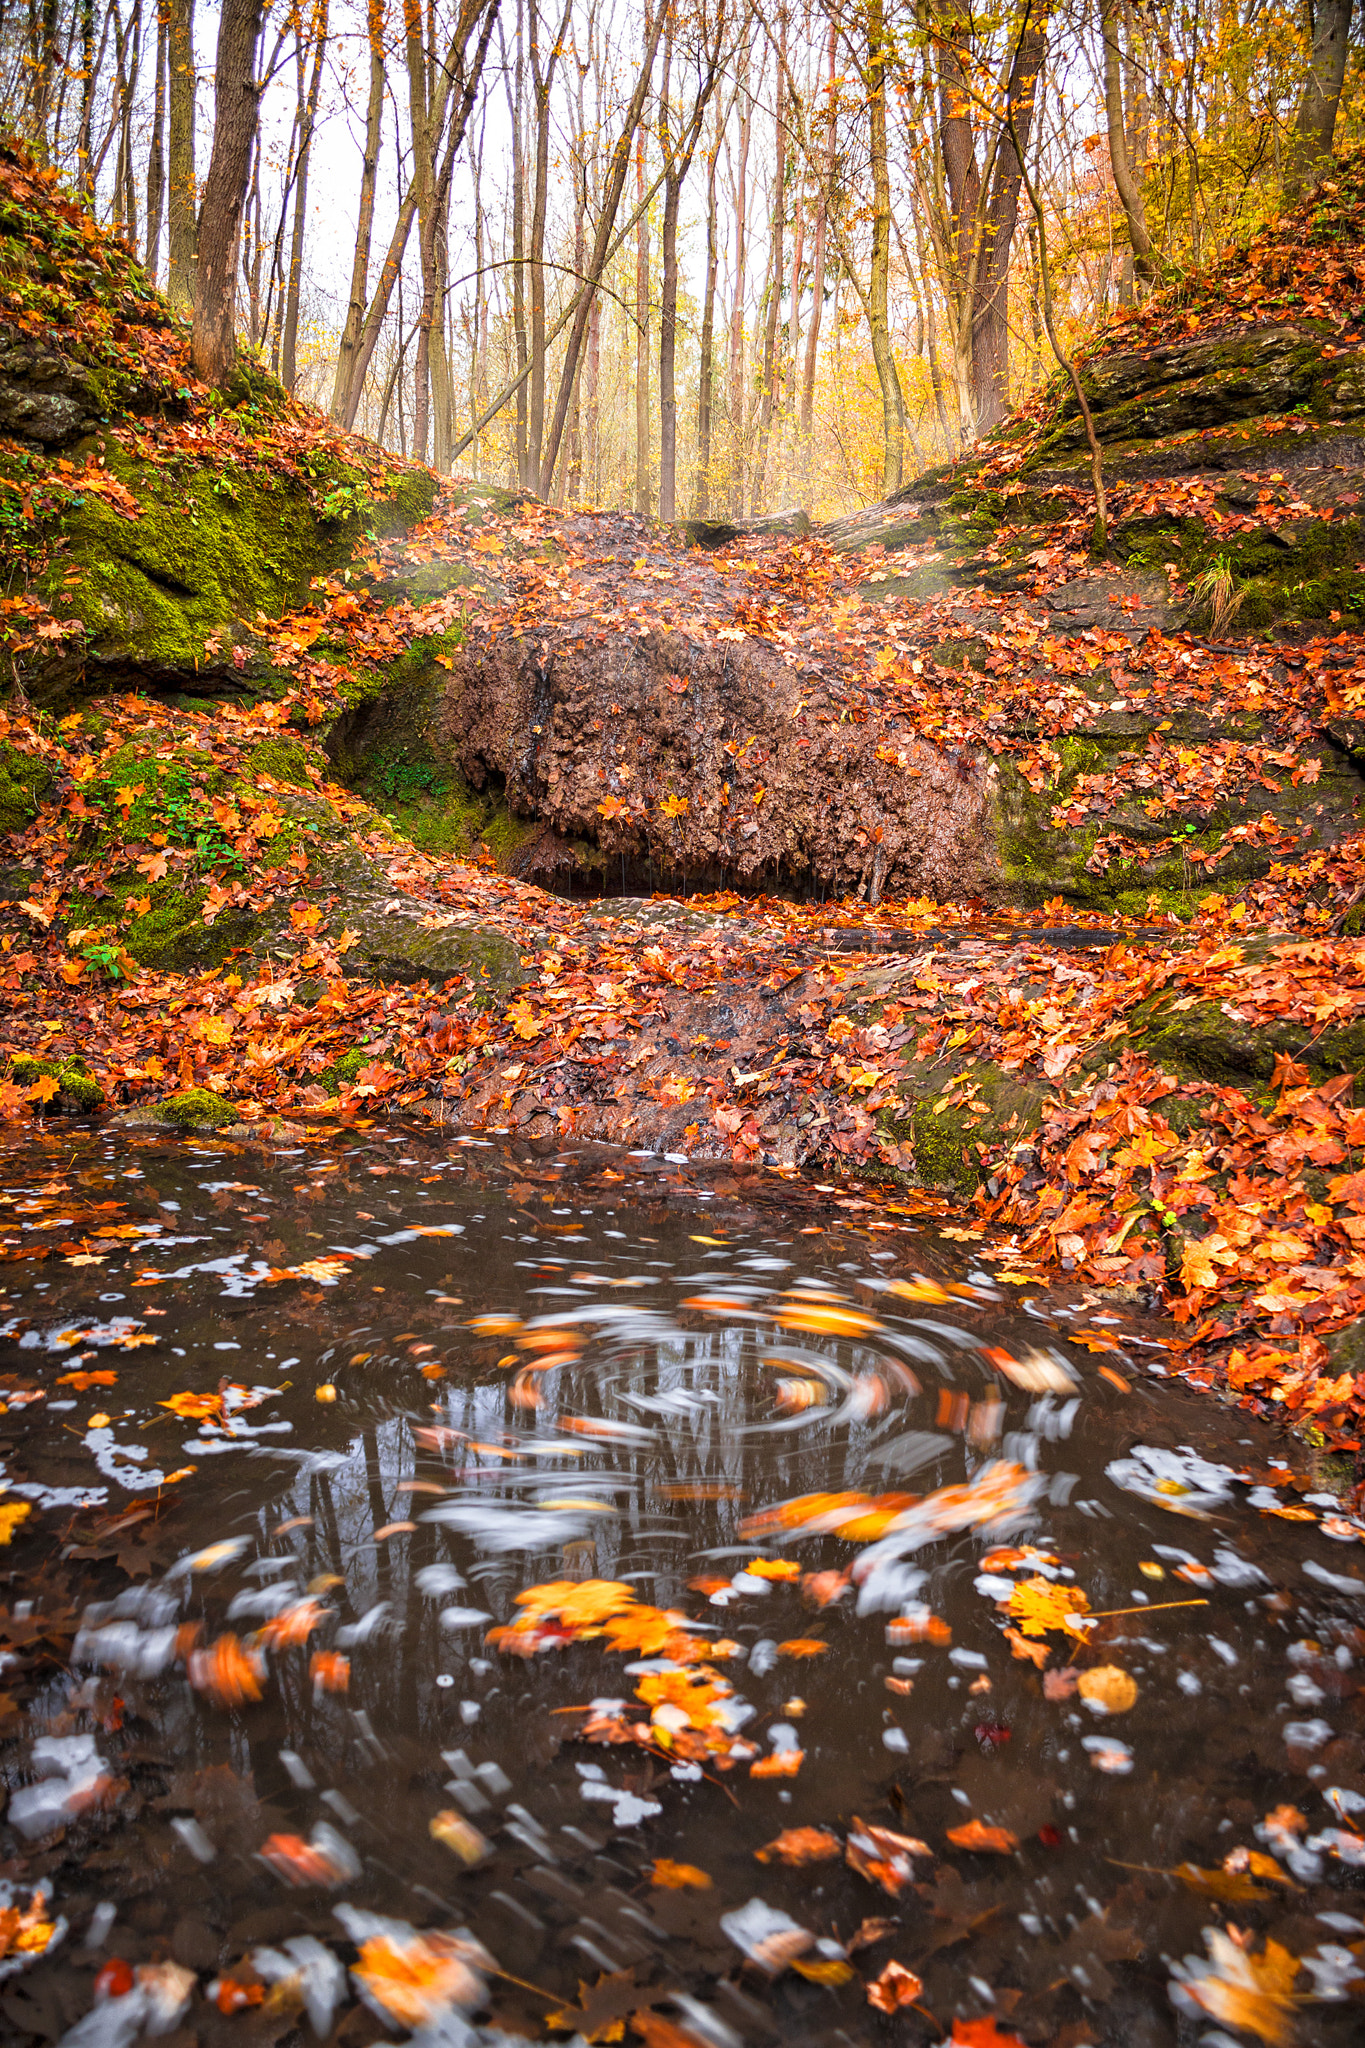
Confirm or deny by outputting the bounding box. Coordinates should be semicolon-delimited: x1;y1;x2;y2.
0;0;1359;518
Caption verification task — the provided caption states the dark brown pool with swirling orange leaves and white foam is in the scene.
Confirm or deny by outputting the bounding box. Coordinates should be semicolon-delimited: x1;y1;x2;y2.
0;1133;1365;2048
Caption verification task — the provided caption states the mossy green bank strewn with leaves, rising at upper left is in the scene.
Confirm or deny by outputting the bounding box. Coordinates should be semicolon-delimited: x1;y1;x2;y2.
0;147;434;705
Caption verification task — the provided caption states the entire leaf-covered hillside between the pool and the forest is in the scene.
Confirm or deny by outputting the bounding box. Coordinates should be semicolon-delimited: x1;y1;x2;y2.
0;144;1365;1450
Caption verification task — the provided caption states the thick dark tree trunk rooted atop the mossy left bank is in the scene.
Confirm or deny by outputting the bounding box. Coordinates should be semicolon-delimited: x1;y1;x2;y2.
190;0;262;389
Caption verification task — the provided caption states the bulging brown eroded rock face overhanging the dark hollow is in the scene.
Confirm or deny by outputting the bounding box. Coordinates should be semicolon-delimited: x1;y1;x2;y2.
432;610;988;901
